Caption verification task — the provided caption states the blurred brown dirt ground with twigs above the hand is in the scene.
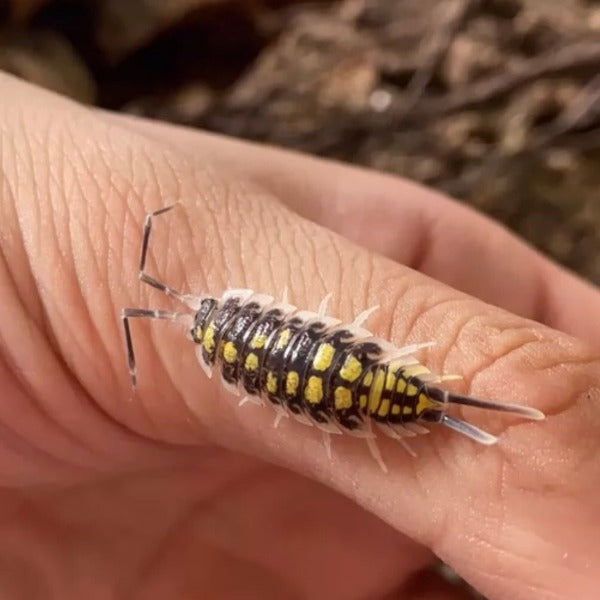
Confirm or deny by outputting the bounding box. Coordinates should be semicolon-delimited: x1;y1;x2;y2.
0;0;600;283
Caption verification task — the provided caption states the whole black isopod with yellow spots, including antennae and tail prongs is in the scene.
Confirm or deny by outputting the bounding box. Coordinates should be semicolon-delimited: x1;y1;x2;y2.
122;207;544;470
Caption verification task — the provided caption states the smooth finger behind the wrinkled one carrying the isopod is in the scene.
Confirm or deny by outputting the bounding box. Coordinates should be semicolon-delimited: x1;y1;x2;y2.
111;116;600;345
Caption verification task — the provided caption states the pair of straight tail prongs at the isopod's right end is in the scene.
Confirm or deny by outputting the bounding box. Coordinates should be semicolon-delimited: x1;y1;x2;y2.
420;386;546;446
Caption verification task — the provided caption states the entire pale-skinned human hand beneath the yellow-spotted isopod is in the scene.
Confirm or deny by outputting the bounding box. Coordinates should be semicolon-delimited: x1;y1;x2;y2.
0;72;600;600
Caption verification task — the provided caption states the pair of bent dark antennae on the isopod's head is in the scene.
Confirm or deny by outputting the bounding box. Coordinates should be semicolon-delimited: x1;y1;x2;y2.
121;203;200;388
